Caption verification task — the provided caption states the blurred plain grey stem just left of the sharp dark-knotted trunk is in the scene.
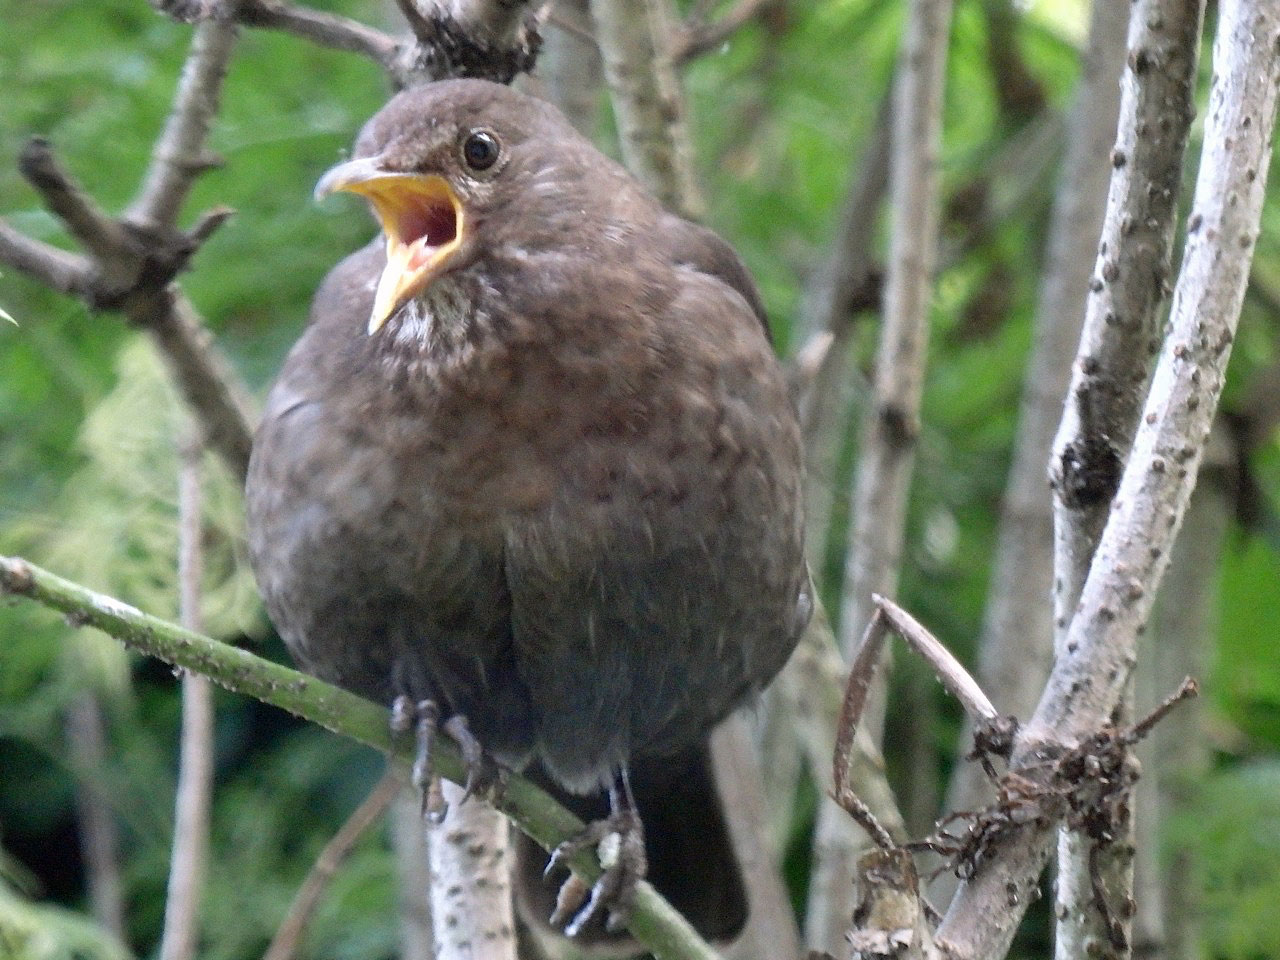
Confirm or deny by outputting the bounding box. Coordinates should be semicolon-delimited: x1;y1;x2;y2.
933;0;1129;904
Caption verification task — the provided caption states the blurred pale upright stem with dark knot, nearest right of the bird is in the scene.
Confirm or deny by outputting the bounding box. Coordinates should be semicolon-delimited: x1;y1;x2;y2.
805;0;951;951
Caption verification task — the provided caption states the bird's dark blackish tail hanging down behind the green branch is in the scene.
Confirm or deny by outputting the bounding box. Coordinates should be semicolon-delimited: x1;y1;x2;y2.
516;744;746;955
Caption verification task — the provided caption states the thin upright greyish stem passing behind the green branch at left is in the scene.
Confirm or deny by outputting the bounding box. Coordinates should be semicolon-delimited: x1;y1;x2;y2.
160;436;214;960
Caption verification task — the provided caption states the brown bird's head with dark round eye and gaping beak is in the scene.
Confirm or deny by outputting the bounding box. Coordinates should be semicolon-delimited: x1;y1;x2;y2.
315;79;593;334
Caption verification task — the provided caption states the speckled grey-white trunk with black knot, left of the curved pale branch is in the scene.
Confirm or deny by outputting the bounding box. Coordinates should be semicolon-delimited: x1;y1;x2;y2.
1053;0;1203;960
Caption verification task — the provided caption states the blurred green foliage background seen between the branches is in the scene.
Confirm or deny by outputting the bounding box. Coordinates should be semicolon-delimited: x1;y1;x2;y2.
0;0;1280;960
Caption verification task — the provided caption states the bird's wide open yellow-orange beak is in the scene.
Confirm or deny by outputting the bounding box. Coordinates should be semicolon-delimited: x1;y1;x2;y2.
315;157;462;334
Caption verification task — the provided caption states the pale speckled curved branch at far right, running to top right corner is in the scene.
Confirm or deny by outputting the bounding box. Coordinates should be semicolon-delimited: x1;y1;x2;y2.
937;0;1280;959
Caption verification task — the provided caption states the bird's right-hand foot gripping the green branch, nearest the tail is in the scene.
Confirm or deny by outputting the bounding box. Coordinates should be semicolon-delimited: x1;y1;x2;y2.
545;788;648;937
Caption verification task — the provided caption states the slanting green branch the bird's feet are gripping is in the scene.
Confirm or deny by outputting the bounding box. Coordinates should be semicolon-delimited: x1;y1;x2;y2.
0;557;718;960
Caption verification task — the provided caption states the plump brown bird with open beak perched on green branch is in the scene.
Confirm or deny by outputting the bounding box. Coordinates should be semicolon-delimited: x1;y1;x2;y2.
247;81;812;938
